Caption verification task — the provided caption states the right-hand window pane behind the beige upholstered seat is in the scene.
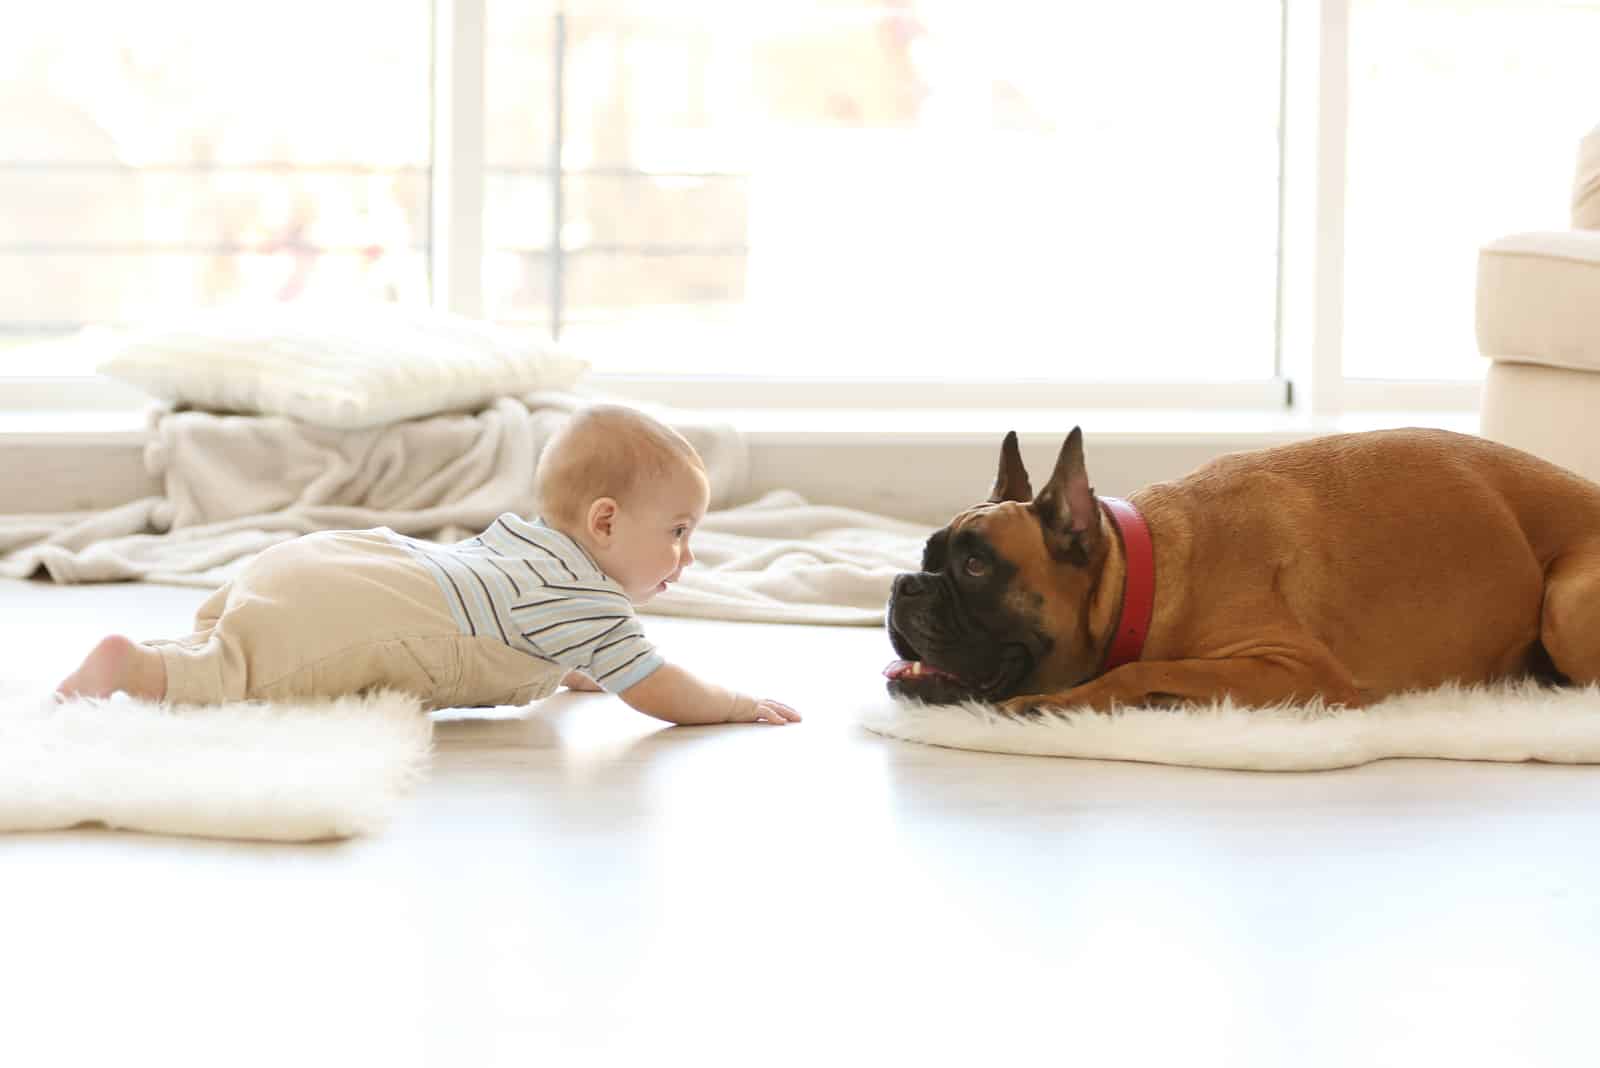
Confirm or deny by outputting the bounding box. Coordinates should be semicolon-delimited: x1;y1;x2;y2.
1344;0;1600;379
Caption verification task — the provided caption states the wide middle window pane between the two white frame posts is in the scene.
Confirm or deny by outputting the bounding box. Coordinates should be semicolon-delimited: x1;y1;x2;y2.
485;0;1280;381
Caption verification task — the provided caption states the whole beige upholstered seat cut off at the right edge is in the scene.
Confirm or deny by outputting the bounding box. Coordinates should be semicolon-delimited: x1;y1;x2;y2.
1477;126;1600;481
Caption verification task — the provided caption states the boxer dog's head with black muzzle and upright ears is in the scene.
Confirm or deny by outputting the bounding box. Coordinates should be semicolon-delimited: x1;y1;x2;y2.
883;427;1107;703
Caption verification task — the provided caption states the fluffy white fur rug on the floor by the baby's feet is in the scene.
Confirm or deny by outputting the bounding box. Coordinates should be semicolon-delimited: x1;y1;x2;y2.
0;689;432;841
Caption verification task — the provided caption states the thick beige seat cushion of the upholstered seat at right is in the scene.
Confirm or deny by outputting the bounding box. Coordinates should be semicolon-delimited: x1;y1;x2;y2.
1477;230;1600;371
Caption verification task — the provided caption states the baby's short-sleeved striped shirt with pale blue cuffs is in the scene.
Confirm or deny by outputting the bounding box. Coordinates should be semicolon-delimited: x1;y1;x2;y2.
384;512;664;694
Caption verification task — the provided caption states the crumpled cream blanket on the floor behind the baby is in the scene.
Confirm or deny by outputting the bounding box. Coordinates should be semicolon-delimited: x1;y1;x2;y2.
0;393;931;625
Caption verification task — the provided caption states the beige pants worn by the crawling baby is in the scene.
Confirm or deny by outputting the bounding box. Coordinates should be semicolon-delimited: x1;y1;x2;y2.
144;531;566;708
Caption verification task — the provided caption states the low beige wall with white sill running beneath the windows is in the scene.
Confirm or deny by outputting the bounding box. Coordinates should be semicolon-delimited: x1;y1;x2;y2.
0;399;1477;524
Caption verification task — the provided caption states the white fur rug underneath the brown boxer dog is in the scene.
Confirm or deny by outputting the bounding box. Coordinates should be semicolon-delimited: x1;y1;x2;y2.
859;683;1600;771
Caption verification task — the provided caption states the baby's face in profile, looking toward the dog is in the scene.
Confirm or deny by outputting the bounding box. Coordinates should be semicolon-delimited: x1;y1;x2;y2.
598;467;710;604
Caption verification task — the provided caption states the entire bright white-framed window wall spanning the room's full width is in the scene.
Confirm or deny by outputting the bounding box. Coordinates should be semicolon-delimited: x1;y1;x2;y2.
0;0;1600;406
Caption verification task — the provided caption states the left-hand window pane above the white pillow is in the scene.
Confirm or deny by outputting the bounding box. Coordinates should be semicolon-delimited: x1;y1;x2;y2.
0;0;432;374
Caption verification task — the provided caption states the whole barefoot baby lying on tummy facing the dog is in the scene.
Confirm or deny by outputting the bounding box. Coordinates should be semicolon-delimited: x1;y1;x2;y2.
56;404;800;724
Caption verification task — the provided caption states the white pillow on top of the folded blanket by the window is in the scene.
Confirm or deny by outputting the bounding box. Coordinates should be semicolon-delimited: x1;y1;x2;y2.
98;305;589;428
